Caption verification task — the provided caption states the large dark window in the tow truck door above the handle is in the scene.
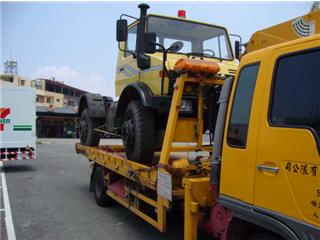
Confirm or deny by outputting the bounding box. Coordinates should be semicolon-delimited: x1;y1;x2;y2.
270;49;320;142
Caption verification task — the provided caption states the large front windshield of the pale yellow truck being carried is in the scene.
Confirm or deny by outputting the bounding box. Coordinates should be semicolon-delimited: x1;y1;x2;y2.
147;16;233;60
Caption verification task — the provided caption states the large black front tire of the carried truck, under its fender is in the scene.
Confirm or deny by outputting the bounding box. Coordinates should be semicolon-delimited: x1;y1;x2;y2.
122;100;157;163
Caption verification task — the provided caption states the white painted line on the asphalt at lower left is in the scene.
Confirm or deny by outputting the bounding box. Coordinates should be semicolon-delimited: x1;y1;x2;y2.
0;161;16;240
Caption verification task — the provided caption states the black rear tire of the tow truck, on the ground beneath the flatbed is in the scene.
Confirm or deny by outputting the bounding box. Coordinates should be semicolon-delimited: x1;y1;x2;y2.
93;166;114;207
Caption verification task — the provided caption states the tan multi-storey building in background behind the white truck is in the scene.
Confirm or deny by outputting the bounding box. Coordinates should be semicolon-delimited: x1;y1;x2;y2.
0;74;86;138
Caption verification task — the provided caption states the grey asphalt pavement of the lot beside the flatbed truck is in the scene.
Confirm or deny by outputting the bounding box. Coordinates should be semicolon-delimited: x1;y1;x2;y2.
4;139;190;240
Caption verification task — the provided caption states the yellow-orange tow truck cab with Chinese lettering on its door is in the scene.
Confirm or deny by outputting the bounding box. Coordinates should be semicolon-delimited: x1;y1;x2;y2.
219;34;320;239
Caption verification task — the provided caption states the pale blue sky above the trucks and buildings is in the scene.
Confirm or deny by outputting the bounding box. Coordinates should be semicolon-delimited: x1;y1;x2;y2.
0;2;312;96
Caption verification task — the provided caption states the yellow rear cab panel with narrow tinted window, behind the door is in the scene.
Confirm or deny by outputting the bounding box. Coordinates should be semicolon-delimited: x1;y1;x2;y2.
220;59;261;203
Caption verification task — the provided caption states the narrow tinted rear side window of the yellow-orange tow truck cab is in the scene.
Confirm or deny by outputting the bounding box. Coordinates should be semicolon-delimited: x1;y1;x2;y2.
227;64;259;148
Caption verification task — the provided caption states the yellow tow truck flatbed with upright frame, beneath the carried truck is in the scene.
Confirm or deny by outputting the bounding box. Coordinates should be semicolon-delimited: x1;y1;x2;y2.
76;71;223;239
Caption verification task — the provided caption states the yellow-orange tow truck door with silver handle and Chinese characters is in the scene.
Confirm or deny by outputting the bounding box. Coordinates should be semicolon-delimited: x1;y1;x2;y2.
255;40;320;226
